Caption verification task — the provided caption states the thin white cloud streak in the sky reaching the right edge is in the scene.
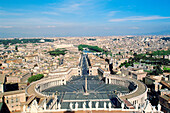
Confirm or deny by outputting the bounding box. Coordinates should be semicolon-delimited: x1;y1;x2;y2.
109;16;170;22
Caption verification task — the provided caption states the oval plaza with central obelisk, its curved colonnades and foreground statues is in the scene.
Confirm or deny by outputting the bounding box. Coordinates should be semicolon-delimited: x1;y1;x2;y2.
23;54;150;113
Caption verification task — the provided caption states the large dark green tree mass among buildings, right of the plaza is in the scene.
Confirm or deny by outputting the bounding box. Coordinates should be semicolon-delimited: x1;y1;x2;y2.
119;50;170;75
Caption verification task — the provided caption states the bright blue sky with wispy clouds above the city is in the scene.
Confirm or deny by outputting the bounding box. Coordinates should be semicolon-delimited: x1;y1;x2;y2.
0;0;170;37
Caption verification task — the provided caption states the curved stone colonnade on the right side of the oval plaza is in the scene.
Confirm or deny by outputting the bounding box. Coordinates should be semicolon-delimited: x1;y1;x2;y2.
105;76;148;106
